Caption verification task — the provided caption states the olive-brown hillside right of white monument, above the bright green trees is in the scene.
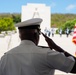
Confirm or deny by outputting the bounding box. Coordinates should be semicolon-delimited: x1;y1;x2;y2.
51;13;76;28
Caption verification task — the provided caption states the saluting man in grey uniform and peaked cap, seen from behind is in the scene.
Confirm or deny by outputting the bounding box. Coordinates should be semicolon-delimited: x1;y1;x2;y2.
0;18;76;75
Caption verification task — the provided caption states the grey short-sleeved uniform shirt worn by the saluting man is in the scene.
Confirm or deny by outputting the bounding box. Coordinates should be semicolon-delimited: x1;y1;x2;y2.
0;40;75;75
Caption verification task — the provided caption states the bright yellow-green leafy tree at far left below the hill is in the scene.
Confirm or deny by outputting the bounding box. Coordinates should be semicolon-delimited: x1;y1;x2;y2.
0;17;15;32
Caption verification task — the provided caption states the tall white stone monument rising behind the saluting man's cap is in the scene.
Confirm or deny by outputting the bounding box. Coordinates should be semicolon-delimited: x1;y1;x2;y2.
21;3;51;32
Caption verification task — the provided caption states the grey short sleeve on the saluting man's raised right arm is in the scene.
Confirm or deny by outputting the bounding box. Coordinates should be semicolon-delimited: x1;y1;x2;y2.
47;51;75;73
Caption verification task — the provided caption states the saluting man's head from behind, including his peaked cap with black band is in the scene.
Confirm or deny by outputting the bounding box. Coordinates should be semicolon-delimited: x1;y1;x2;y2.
16;18;42;45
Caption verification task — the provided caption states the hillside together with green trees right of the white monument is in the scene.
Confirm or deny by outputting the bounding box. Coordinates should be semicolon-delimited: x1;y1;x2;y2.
51;14;76;33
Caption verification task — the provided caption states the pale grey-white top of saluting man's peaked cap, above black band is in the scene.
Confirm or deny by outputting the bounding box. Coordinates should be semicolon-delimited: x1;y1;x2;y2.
15;18;43;27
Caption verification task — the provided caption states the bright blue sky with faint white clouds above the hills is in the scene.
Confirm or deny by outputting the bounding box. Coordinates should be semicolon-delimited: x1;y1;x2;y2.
0;0;76;14
